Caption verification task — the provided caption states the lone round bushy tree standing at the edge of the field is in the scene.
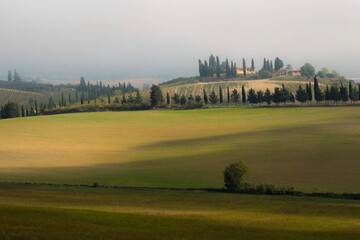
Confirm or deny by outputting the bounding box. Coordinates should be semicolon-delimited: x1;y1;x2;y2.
224;162;249;191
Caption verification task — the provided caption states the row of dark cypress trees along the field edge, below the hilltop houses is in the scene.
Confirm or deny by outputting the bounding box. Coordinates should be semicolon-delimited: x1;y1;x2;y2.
150;77;360;107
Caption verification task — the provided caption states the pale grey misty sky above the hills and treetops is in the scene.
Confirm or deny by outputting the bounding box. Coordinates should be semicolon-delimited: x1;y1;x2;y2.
0;0;360;80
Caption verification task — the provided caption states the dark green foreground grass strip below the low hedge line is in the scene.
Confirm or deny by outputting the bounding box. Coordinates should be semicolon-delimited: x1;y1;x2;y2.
0;184;360;240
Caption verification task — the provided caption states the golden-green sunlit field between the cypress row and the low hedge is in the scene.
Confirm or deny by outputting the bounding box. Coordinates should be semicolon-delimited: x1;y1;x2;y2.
0;107;360;192
